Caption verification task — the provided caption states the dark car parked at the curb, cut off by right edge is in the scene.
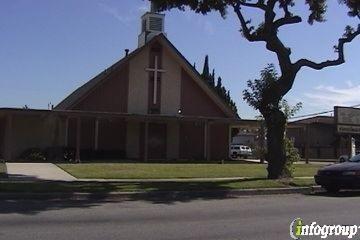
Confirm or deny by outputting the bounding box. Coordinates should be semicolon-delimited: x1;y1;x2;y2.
314;154;360;192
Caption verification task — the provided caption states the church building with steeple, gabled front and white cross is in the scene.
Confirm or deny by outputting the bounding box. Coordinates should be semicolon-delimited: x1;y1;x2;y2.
0;3;242;161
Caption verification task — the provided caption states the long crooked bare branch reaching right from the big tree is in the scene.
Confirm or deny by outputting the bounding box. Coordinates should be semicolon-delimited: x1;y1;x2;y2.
294;24;360;71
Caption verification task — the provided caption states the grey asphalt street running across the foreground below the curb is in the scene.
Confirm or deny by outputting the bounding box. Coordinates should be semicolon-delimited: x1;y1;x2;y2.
0;192;360;240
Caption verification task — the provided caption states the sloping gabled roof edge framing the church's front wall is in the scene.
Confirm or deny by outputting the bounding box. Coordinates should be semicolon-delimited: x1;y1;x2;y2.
55;34;238;118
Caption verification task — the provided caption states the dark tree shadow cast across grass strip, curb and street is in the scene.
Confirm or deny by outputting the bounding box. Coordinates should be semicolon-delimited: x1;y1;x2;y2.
0;179;263;215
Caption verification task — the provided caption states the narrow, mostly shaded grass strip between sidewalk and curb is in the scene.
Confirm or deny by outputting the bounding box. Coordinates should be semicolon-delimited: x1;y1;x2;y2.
0;178;314;193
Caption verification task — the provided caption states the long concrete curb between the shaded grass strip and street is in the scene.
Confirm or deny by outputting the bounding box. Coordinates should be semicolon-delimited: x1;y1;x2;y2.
0;186;321;201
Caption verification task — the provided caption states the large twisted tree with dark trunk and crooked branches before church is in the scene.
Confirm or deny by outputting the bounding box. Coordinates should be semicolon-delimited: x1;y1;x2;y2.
153;0;360;179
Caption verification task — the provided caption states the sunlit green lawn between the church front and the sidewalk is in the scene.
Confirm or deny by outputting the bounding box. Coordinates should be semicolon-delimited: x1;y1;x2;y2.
58;163;322;179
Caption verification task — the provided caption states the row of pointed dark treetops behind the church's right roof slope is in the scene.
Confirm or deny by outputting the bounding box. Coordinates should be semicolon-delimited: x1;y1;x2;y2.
201;55;238;115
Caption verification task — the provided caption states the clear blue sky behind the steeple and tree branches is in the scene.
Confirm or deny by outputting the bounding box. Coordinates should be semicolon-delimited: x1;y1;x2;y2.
0;0;360;118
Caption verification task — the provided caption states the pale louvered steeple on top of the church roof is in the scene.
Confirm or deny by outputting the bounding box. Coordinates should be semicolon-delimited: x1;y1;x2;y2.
138;1;165;47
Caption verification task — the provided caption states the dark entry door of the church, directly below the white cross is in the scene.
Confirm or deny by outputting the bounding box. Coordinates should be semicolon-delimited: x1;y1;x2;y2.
148;123;166;159
